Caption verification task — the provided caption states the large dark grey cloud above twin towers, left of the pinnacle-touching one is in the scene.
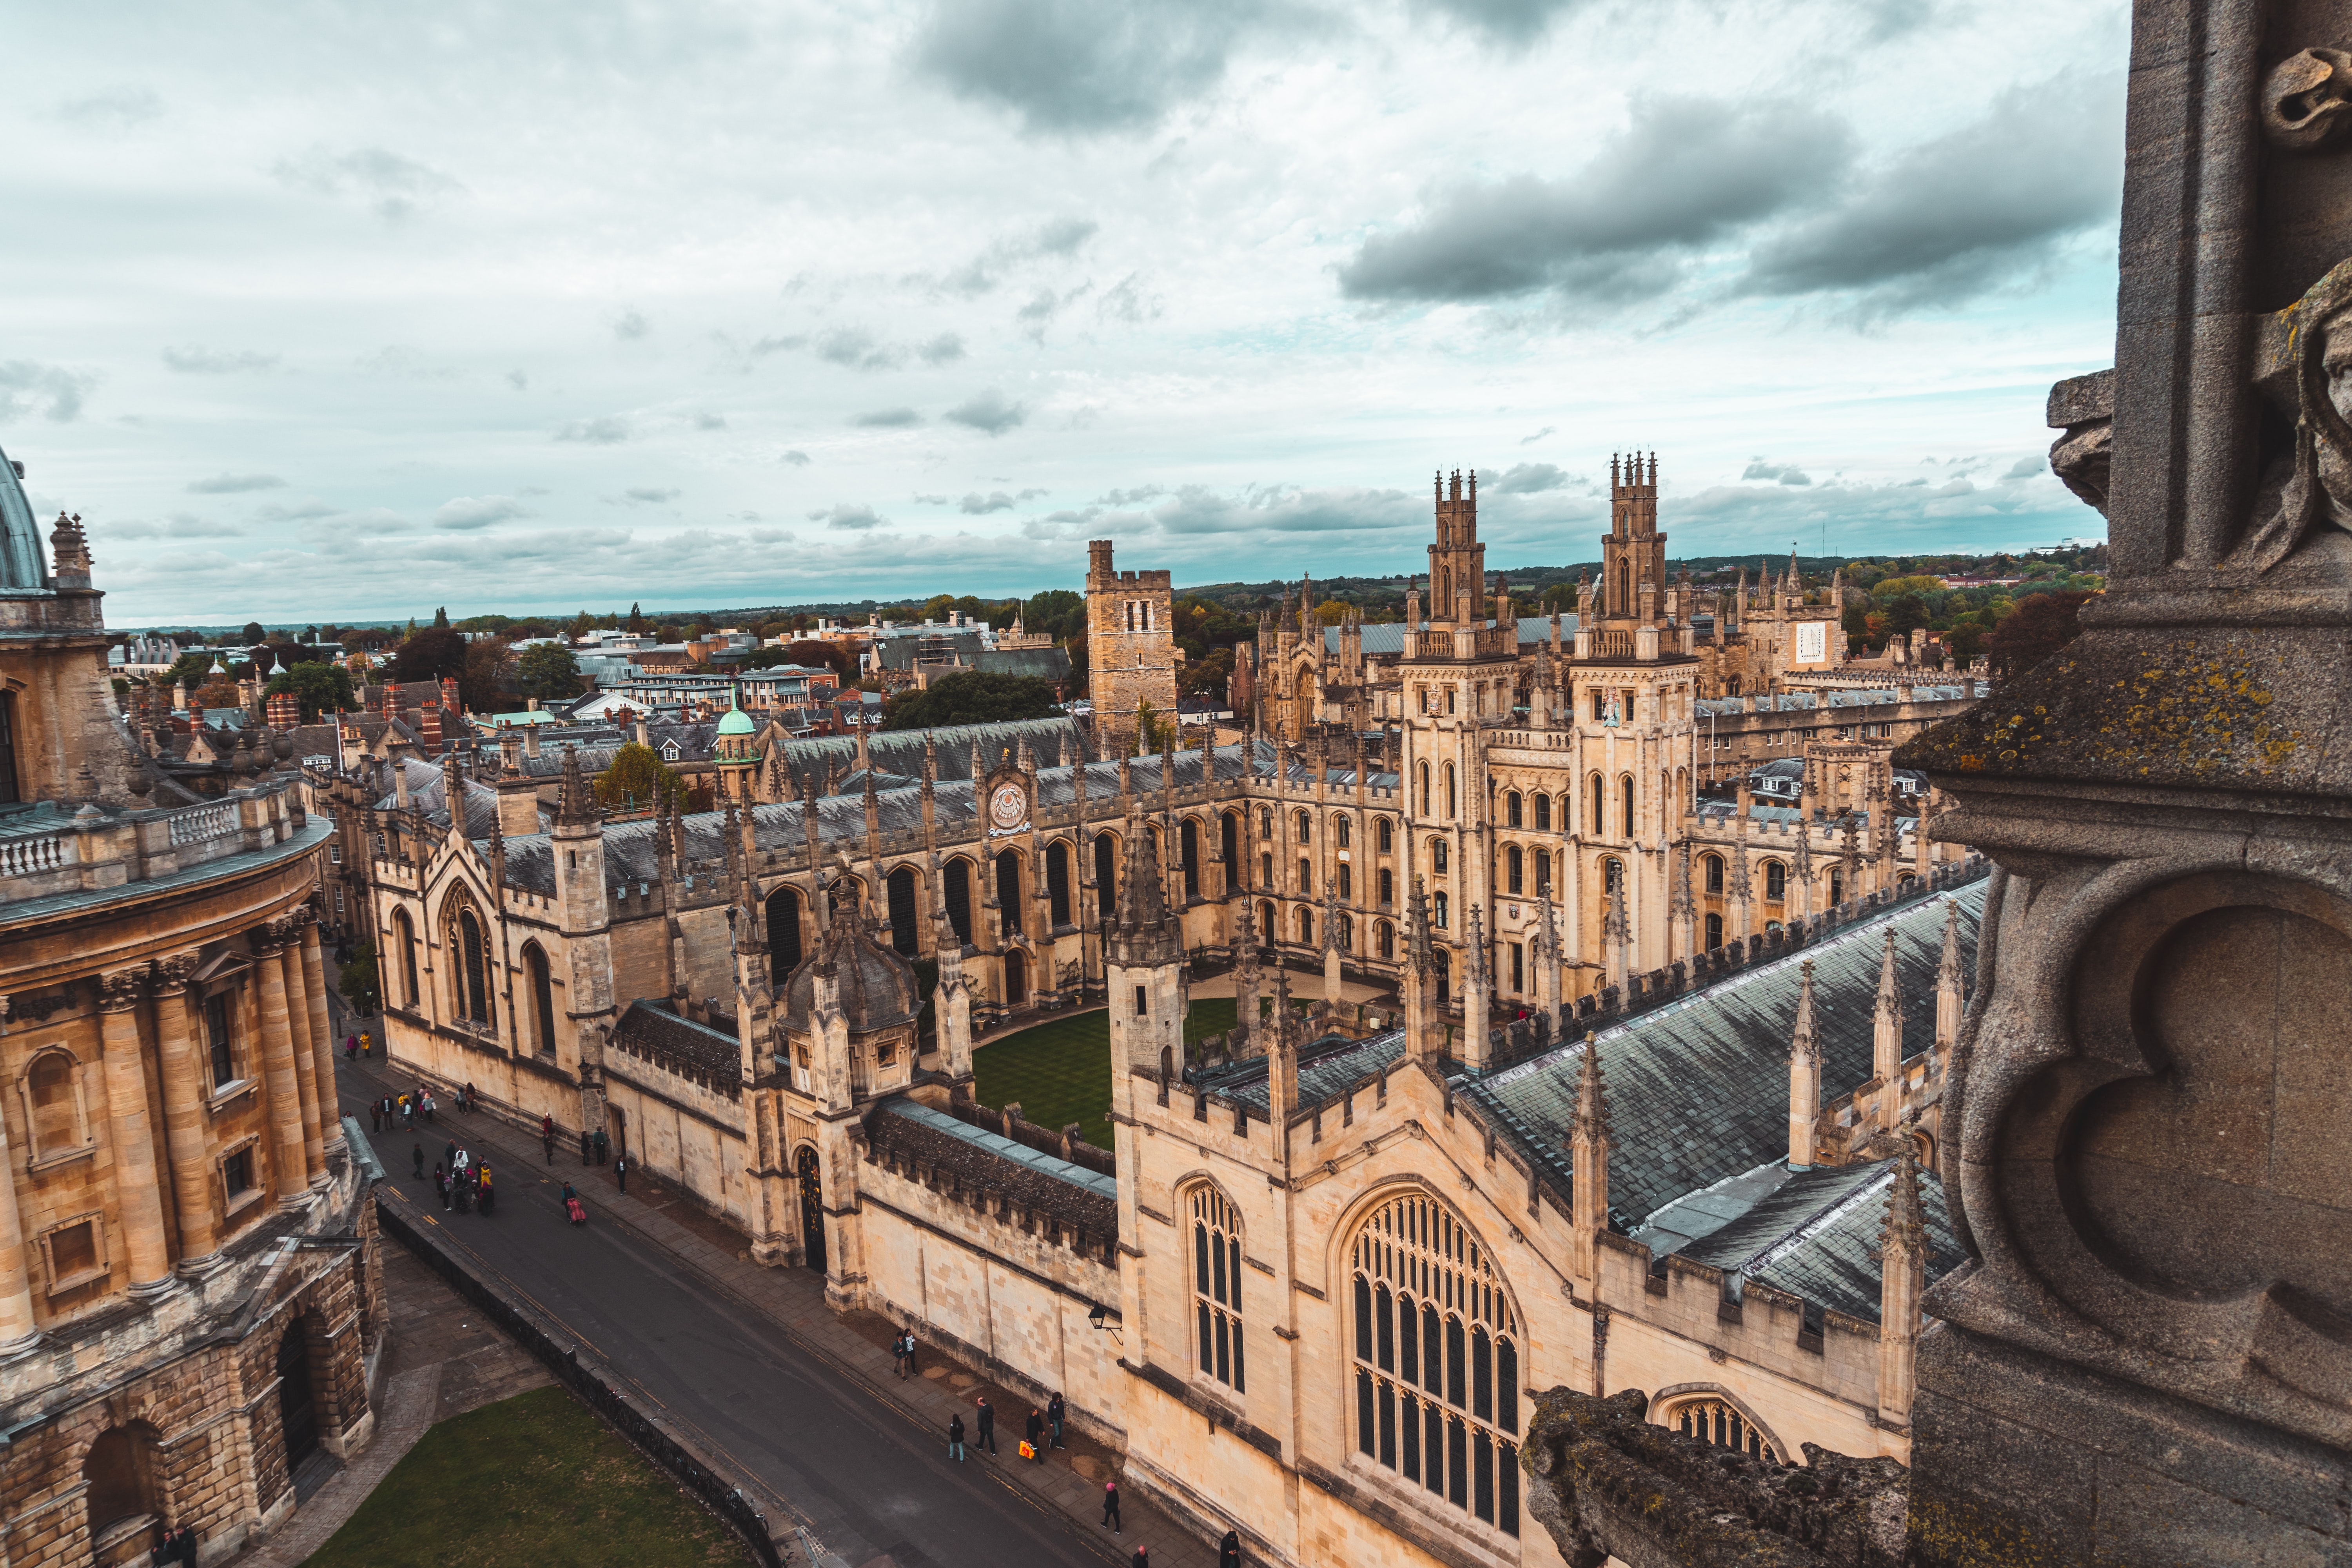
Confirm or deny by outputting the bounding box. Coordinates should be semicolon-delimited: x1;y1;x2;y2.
1338;96;1853;301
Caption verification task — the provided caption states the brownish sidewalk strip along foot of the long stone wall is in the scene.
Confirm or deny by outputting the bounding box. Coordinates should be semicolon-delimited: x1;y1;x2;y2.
343;1044;1216;1568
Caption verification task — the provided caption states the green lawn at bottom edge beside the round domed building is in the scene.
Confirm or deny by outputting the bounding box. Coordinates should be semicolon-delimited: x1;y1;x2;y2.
306;1387;750;1568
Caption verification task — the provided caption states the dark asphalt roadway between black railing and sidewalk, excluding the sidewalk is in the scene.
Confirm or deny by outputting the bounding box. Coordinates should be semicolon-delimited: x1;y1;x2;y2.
336;1060;1127;1568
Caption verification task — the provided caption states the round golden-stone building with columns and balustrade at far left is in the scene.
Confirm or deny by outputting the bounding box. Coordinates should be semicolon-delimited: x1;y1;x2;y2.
0;444;383;1568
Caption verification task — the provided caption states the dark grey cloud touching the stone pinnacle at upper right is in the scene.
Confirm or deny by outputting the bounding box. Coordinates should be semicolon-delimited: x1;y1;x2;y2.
1740;75;2124;320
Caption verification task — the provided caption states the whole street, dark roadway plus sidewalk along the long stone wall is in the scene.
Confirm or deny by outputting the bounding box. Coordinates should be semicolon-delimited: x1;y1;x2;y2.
336;1030;1214;1568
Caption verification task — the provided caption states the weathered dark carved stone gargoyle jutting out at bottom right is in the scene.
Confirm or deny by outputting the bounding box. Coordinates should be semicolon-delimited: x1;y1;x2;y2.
1519;1389;1910;1568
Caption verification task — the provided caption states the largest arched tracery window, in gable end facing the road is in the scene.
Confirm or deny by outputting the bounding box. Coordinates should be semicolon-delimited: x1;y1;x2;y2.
1350;1194;1519;1535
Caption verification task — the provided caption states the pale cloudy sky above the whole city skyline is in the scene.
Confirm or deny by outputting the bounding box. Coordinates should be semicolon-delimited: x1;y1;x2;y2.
0;0;2126;625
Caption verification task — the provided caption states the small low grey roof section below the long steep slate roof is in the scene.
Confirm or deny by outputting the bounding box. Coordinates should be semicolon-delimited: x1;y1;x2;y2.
1684;1159;1966;1323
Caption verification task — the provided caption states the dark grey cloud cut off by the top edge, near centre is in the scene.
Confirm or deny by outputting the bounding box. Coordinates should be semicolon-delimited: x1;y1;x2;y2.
915;0;1263;132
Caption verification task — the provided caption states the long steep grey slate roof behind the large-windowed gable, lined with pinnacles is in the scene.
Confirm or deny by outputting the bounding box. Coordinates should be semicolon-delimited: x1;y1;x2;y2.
1461;879;1985;1229
